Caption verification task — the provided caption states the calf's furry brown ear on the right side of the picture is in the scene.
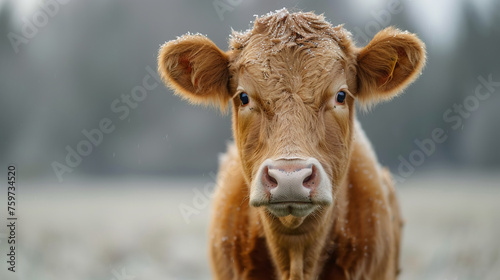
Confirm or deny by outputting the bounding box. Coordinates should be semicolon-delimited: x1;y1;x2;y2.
357;27;426;105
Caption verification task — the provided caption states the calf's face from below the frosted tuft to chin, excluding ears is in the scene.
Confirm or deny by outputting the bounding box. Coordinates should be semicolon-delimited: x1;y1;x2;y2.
231;42;354;217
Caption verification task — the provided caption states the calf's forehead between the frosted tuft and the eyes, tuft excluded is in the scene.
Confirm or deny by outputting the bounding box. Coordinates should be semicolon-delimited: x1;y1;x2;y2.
232;41;348;103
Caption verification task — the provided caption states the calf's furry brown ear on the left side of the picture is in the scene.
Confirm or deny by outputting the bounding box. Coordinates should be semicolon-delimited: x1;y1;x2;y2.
158;35;231;109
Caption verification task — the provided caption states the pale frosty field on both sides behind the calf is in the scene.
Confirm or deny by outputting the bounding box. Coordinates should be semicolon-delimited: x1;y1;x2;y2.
0;174;500;280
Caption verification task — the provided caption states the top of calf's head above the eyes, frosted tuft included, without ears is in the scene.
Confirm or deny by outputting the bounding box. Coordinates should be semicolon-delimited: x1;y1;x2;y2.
225;10;355;100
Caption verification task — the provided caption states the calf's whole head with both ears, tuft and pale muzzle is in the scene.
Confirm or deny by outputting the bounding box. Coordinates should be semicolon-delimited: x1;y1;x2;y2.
159;10;425;225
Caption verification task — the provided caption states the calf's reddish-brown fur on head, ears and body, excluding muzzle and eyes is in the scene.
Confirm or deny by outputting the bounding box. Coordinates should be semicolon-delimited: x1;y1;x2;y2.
158;10;425;279
